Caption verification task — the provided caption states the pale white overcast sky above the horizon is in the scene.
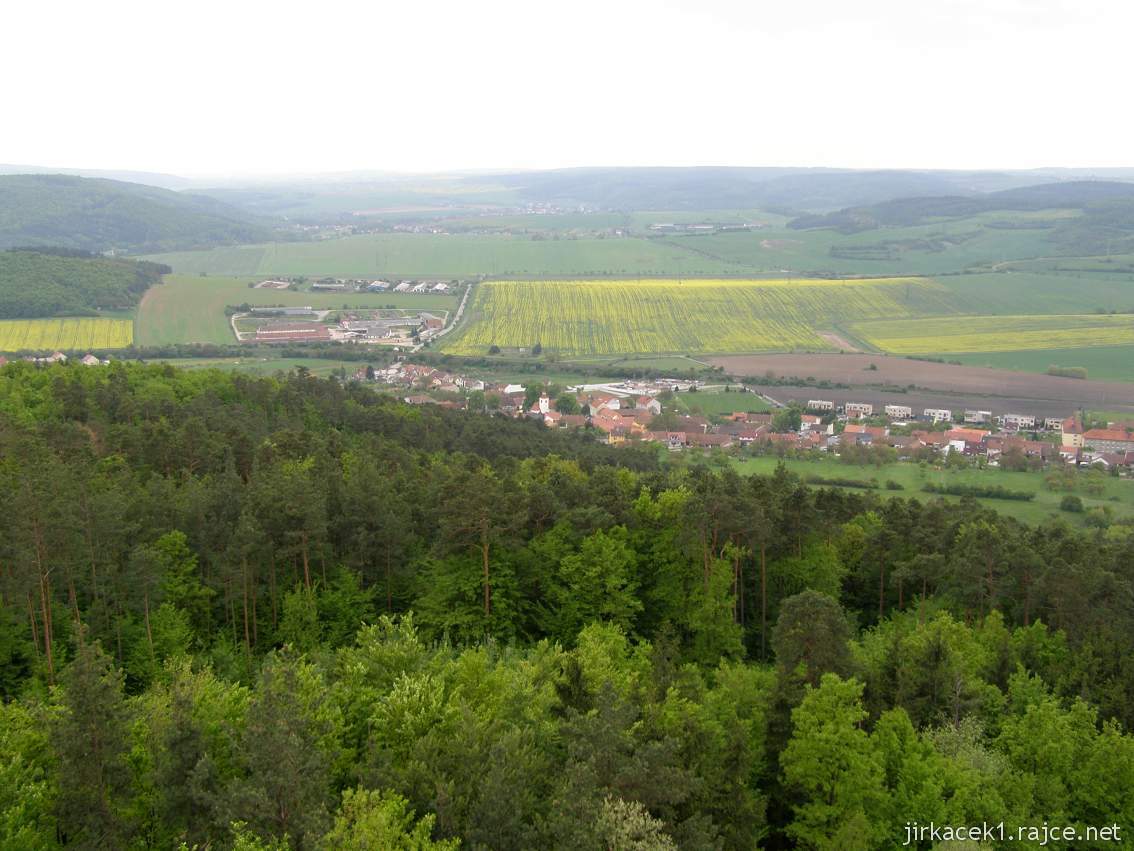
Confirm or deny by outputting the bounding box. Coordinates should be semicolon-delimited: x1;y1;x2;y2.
0;0;1134;175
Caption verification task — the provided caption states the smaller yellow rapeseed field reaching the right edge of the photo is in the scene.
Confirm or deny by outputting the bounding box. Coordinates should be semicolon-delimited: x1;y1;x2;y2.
849;314;1134;354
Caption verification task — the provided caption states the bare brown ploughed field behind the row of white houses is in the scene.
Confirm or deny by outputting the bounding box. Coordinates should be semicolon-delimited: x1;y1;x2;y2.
706;354;1134;410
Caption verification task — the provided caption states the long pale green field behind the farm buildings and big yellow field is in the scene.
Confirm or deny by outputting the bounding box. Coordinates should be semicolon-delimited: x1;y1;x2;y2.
141;234;744;278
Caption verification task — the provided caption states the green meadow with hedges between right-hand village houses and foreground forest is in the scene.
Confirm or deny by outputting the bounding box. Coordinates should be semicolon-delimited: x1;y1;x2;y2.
736;456;1134;523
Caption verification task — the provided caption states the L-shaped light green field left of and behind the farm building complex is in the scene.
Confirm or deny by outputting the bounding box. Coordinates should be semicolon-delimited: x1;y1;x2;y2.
135;275;457;346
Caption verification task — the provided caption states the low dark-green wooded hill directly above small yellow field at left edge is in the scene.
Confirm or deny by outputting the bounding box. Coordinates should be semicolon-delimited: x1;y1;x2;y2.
0;248;171;319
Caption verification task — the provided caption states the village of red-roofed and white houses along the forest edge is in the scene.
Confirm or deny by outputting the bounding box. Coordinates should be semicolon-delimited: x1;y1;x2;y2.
354;361;1134;475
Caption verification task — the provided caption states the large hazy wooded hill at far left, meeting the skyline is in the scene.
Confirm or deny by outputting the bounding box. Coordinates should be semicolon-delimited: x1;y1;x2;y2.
0;175;272;253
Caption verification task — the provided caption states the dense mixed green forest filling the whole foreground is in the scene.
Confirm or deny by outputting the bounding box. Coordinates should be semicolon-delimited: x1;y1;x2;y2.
0;363;1134;851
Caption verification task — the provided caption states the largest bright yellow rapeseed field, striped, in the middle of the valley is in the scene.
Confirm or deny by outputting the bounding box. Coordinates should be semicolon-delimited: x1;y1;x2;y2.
443;278;956;355
